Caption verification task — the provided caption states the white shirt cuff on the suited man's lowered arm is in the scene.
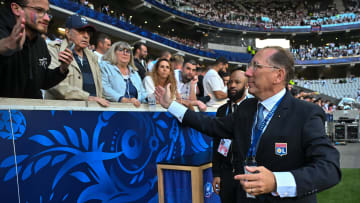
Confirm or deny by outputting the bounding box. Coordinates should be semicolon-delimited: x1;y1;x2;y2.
271;172;296;198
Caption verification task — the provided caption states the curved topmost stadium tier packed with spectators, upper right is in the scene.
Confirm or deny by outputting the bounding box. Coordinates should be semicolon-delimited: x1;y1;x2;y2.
144;0;360;34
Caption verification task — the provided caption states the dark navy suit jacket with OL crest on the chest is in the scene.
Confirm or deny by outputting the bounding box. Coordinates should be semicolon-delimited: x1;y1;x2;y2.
182;92;341;203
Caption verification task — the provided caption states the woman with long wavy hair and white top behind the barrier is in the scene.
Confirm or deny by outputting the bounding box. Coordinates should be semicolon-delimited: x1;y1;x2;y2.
143;58;180;103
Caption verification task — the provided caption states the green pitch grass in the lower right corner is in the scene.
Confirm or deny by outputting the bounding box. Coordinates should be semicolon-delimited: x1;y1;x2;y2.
317;168;360;203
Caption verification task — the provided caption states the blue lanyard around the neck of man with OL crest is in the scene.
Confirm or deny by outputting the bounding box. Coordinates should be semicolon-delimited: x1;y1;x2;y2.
247;97;283;160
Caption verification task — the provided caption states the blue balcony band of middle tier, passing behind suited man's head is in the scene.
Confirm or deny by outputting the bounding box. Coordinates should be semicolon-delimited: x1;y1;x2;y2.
50;0;360;66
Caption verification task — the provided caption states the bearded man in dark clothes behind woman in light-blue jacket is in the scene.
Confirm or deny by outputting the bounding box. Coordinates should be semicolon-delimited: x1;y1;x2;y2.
133;42;148;80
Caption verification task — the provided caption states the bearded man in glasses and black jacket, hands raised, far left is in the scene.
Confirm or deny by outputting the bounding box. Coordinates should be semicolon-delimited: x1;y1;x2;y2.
0;0;73;99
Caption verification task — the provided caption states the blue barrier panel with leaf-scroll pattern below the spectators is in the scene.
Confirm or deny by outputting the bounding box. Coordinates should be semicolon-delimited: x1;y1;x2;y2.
0;110;214;203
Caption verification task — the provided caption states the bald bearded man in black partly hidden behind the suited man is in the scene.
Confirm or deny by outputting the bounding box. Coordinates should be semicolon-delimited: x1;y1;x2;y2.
212;69;248;203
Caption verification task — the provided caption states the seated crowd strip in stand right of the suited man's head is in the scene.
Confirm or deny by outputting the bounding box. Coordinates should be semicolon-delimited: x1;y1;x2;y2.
291;41;360;60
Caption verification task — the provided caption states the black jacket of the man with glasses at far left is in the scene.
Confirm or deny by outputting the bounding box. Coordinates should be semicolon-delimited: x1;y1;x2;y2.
0;8;66;99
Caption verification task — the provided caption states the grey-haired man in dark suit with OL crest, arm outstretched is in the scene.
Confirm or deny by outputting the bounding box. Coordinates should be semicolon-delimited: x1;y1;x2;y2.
156;47;341;203
